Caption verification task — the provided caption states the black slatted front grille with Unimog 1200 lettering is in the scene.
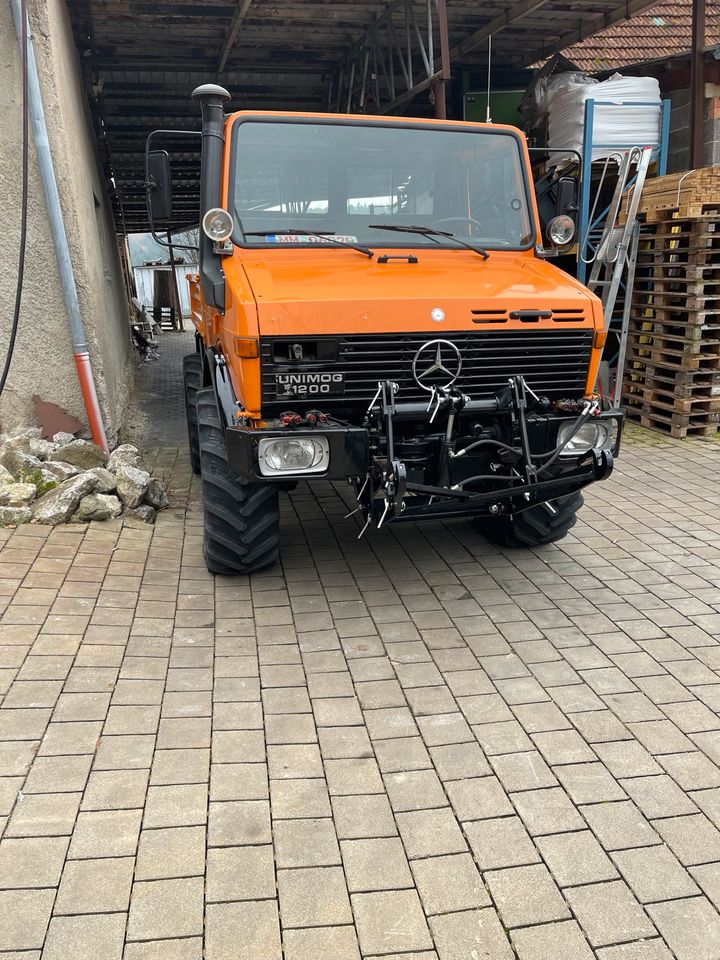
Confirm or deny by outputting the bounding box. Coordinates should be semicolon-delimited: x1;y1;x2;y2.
261;329;593;409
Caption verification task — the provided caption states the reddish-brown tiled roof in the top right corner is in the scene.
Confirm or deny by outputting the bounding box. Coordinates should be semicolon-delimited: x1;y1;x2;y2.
563;0;720;73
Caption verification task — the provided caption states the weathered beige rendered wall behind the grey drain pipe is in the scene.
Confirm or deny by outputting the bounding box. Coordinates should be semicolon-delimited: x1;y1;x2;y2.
0;0;132;439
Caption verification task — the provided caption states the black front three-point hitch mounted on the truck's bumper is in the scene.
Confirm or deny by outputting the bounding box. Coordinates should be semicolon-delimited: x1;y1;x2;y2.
353;376;613;537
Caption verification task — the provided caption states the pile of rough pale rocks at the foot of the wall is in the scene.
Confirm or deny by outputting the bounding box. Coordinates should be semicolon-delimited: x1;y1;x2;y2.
0;427;168;526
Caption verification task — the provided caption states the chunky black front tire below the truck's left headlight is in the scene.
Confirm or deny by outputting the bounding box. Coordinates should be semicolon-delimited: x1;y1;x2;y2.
196;387;280;574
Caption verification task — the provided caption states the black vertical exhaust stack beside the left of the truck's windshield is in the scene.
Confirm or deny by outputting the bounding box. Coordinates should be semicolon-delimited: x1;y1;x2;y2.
192;83;230;310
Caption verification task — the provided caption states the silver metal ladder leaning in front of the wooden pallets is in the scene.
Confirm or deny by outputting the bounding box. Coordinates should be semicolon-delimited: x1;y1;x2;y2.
580;146;653;408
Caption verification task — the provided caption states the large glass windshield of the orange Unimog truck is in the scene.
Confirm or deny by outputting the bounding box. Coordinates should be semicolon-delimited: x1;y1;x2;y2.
230;120;534;249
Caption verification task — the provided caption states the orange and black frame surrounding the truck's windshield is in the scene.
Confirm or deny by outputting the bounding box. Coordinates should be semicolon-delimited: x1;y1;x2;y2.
225;112;539;253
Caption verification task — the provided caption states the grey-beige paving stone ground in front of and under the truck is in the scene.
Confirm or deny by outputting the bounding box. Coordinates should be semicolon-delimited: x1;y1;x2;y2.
0;335;720;960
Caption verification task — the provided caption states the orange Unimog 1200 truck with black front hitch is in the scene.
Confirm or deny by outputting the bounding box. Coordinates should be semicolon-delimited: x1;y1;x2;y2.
147;84;621;574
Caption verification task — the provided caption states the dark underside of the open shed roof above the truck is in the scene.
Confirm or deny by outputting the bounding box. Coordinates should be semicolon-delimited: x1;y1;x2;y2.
66;0;664;231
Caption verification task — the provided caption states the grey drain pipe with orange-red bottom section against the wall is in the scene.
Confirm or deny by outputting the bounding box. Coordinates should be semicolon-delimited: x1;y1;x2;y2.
10;0;109;453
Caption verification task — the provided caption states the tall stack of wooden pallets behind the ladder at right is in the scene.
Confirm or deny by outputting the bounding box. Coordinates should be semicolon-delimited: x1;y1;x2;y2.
623;166;720;437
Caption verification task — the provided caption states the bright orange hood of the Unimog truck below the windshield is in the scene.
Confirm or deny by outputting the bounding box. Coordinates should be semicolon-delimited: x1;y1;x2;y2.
231;248;600;336
